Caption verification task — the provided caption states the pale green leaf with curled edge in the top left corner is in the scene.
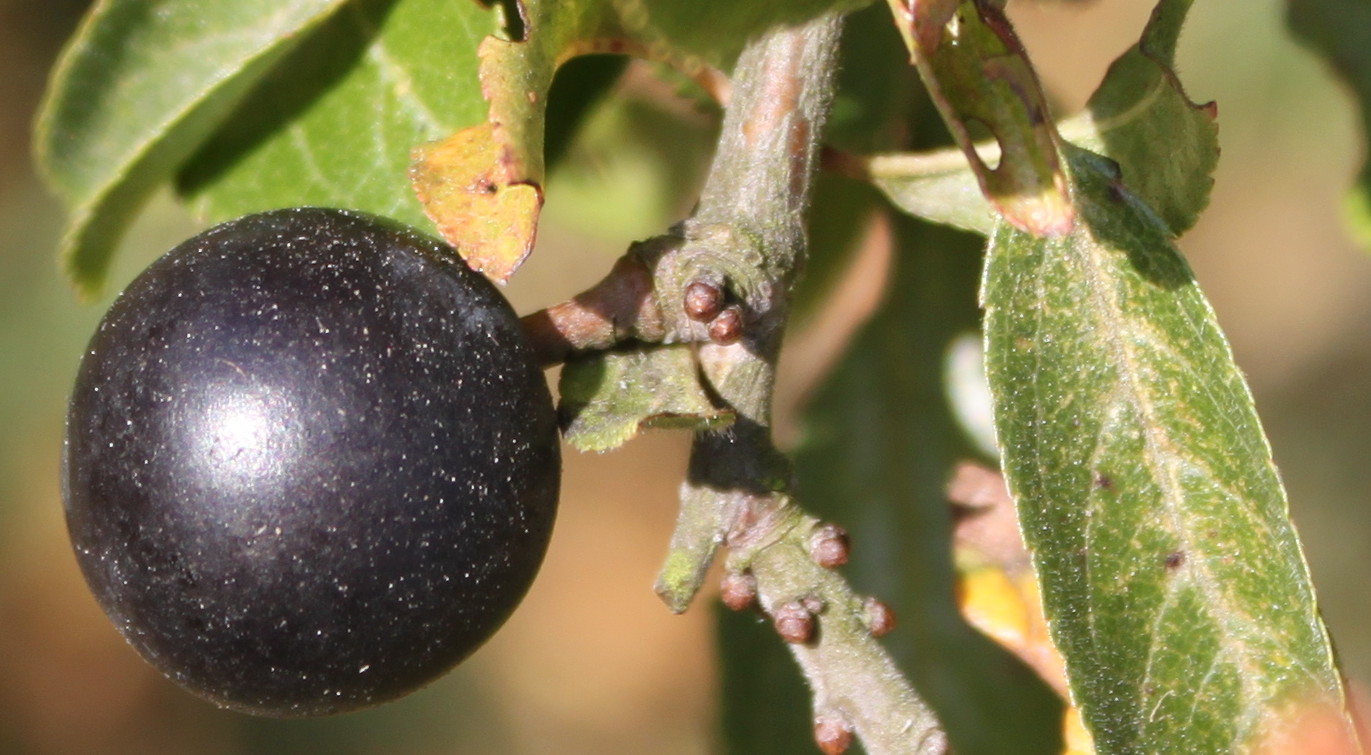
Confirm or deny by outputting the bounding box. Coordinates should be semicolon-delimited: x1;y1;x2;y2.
36;0;341;295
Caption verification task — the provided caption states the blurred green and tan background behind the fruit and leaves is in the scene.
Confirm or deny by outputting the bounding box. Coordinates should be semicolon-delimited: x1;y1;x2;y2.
0;0;1371;755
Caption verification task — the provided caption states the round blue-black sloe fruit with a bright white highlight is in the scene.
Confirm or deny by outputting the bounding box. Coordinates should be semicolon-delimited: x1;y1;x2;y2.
63;208;561;715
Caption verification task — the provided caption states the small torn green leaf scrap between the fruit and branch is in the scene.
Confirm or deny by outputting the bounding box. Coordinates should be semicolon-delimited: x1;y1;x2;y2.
558;345;733;451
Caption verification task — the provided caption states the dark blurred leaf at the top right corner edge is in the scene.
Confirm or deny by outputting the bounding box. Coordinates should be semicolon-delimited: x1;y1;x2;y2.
1286;0;1371;247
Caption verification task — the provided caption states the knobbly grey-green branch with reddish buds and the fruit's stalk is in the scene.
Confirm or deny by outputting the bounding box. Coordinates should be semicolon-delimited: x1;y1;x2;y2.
524;15;947;755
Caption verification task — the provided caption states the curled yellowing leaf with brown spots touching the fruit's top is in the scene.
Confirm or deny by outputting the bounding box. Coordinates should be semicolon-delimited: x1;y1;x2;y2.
413;0;871;281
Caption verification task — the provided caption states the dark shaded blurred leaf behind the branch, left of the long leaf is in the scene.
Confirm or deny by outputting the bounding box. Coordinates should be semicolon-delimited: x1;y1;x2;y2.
784;212;1060;755
